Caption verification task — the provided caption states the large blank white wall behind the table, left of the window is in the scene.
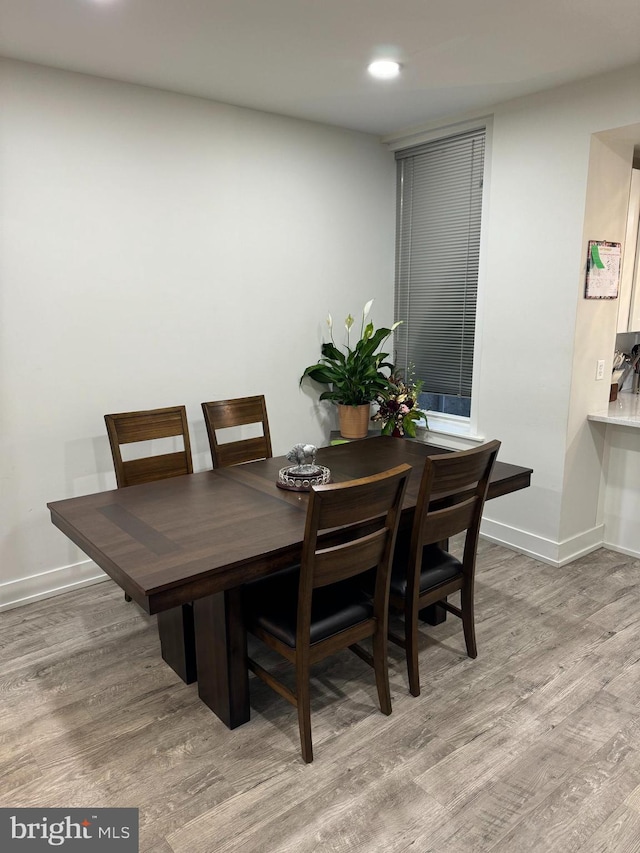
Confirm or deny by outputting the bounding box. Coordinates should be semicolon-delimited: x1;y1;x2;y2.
0;61;395;606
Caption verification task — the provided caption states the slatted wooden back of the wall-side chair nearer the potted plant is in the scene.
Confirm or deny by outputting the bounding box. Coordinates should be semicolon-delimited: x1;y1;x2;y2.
202;394;272;468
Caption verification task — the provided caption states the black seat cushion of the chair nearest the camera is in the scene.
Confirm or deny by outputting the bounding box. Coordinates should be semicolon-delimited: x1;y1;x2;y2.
244;566;373;649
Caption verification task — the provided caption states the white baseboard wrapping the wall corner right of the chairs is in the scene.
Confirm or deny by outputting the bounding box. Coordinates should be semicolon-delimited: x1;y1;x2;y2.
481;519;610;567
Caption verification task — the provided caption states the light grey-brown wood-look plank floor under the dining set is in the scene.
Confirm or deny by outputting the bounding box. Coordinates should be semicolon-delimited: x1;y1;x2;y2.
0;542;640;853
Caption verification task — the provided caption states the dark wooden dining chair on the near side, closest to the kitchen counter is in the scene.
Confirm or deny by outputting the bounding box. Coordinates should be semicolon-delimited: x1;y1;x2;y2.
389;441;500;696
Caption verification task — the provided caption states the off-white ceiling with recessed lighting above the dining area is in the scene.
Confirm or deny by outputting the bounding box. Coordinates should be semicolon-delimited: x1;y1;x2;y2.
0;0;640;135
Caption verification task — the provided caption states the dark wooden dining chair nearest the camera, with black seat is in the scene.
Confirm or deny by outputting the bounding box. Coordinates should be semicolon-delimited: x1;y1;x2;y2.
240;465;411;763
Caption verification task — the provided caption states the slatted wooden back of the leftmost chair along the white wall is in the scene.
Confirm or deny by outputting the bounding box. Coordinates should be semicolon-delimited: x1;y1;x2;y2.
104;406;193;488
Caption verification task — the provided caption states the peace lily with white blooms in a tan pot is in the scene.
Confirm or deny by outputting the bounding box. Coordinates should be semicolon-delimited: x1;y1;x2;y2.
300;299;399;438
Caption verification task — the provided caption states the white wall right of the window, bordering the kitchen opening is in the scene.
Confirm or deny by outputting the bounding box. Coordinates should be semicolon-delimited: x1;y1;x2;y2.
464;66;640;563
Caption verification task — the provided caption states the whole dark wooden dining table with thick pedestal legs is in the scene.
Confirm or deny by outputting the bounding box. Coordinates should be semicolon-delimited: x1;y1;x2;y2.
47;436;532;728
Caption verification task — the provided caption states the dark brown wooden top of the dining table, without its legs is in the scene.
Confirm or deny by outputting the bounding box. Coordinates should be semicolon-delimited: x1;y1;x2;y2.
47;436;532;613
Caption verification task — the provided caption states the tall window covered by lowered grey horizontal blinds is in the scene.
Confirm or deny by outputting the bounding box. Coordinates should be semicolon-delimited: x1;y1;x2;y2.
395;128;486;417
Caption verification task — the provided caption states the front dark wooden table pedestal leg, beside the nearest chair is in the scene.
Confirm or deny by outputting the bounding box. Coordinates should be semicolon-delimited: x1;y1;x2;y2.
193;587;250;729
